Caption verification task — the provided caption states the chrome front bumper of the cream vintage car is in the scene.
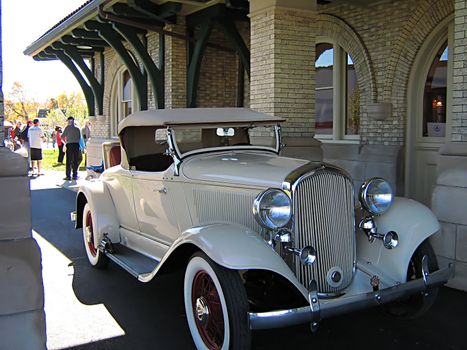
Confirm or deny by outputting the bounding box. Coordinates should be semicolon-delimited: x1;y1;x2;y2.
249;257;454;329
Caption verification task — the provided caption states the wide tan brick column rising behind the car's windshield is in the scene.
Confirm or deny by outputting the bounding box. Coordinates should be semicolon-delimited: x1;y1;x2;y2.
250;0;321;159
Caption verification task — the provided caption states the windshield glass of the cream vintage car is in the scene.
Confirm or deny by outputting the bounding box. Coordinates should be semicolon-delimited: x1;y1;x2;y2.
173;125;278;156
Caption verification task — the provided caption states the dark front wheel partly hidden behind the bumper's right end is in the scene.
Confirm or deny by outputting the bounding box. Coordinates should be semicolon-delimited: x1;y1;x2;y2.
385;240;438;319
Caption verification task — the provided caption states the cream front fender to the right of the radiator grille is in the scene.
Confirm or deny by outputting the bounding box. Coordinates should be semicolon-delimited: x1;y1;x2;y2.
357;197;440;283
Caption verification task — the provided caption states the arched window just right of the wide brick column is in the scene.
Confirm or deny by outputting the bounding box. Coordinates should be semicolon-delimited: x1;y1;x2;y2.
315;41;360;140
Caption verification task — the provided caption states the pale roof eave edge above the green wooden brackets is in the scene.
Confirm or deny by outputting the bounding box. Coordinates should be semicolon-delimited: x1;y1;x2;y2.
23;0;118;57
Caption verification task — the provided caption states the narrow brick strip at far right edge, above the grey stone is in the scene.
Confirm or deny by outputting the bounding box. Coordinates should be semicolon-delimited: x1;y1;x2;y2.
451;0;467;141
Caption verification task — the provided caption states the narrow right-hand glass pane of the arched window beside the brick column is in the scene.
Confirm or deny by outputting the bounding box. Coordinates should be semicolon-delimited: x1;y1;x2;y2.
345;55;360;135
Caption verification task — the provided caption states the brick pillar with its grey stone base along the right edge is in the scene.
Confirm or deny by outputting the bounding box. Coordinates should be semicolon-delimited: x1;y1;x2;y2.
431;0;467;291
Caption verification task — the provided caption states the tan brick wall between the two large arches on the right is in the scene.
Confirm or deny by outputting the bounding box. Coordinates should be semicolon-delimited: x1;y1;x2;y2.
318;0;454;145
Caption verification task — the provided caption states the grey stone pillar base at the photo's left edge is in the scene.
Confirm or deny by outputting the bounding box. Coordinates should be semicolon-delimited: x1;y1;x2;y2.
0;147;46;350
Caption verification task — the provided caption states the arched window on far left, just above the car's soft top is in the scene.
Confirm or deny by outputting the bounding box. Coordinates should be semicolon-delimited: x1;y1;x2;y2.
111;67;137;136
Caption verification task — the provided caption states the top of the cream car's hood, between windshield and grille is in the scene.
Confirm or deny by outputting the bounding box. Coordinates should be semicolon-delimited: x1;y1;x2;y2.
181;151;316;188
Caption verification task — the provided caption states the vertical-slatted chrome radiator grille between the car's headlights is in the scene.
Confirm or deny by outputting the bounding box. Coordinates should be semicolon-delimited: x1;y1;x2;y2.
293;168;356;293
